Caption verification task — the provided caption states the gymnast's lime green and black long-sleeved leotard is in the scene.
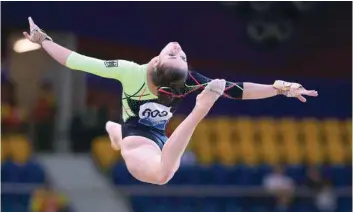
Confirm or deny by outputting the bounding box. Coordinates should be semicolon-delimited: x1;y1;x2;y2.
66;52;243;149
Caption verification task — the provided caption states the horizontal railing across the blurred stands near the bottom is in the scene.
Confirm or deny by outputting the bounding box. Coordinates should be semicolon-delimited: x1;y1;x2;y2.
1;183;352;197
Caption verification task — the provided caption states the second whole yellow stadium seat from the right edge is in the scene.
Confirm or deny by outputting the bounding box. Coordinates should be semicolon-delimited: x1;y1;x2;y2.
300;118;324;165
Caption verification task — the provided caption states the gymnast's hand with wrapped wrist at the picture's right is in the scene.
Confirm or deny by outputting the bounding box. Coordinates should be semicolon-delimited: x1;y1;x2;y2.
273;80;319;102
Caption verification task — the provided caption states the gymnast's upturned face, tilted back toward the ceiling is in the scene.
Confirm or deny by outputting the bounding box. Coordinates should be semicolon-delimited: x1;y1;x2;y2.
158;42;188;70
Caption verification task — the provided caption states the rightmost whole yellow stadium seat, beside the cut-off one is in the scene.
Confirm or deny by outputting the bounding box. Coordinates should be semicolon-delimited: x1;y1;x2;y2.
322;119;347;164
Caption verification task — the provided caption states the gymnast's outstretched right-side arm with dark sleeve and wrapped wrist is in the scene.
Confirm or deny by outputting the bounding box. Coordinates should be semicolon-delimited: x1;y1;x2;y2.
186;71;318;102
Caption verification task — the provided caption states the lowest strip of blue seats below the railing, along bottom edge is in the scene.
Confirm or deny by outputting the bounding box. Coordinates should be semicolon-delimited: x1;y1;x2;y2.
128;197;352;212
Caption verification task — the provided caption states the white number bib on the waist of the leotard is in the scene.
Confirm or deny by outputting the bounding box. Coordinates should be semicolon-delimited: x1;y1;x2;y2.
139;102;173;130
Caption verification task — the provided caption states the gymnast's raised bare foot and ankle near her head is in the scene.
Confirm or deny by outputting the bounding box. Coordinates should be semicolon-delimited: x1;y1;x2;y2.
194;79;226;116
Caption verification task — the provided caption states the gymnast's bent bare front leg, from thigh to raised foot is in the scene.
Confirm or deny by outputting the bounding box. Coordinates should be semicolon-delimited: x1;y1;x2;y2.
121;80;225;185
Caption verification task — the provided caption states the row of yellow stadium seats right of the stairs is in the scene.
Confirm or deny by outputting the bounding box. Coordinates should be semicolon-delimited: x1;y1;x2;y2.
92;117;352;168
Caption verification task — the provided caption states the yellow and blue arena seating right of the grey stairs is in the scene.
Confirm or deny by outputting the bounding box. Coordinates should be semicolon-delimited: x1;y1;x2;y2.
92;118;352;212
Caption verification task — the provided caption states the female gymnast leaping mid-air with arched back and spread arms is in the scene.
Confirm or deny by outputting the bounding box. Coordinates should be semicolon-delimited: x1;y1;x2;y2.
23;18;318;185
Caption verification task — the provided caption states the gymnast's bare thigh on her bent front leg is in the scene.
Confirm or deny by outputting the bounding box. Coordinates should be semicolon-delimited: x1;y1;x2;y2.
121;136;162;183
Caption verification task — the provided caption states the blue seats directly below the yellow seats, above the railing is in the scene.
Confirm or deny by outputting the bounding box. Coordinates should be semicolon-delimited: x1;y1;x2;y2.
111;163;352;187
